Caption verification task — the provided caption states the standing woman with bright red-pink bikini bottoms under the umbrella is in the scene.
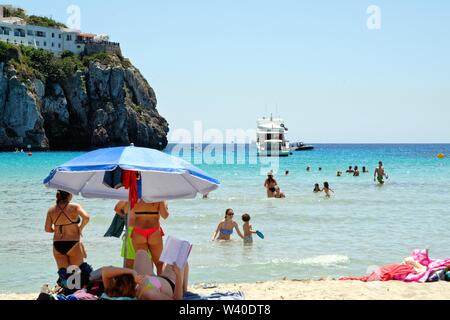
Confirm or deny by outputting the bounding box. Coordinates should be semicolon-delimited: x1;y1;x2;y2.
130;201;169;275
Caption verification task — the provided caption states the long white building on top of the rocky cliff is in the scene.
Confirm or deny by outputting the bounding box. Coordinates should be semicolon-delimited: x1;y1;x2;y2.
0;5;120;54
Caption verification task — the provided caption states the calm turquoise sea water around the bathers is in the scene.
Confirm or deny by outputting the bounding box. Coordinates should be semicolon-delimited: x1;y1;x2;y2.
0;145;450;293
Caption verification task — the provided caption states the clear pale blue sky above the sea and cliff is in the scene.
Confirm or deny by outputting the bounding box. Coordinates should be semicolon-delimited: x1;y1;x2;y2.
13;0;450;143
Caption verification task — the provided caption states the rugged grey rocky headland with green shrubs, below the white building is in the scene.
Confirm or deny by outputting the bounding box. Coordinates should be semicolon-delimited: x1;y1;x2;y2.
0;42;169;150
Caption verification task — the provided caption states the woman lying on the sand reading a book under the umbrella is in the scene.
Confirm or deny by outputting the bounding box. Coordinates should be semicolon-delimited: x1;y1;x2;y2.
102;250;189;300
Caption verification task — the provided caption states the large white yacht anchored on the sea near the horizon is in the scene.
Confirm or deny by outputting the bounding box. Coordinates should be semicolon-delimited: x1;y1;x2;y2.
256;115;291;157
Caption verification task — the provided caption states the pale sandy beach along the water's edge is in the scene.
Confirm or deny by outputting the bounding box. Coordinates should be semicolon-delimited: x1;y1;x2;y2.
0;280;450;300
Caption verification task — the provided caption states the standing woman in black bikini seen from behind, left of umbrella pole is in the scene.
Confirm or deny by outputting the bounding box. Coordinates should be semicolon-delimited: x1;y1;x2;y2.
45;190;89;273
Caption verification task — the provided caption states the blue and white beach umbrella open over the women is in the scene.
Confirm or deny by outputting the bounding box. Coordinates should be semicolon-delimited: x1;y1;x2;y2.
44;146;220;202
